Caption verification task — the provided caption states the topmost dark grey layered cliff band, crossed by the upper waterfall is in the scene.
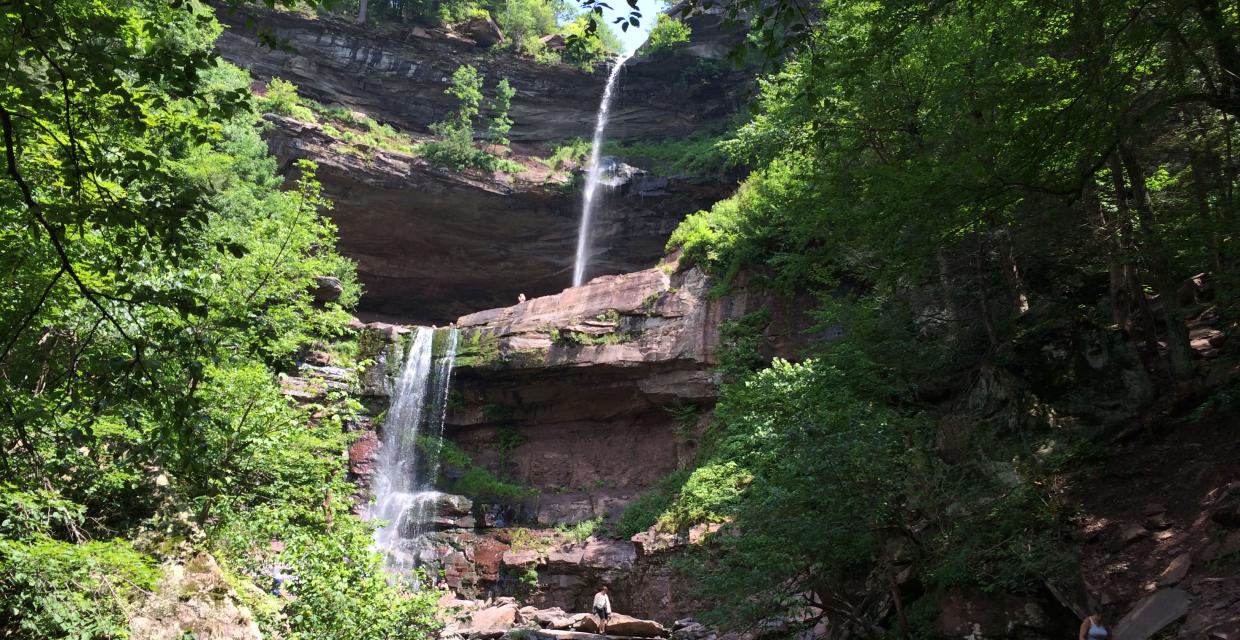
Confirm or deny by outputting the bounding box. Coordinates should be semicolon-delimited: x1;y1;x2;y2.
216;9;751;141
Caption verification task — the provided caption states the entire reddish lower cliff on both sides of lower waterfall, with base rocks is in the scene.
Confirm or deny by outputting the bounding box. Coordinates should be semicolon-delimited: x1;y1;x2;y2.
350;258;813;624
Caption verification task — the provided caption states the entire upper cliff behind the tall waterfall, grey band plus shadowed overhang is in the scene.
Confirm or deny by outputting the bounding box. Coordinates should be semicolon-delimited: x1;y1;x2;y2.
217;9;750;324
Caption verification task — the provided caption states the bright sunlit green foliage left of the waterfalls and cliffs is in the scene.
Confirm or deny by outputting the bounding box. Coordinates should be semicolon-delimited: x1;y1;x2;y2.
0;0;434;639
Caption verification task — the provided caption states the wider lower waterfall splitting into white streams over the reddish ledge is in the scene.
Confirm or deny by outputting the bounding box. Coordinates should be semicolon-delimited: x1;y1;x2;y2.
367;326;458;572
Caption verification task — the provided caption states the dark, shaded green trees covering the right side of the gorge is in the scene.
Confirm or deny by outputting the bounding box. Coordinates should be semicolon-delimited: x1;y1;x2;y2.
635;0;1240;634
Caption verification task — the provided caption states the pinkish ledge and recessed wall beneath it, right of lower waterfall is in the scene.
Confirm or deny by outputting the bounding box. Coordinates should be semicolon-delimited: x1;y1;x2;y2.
448;257;808;523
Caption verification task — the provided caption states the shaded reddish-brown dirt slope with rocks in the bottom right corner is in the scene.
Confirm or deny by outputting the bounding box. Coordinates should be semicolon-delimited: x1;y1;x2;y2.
1075;407;1240;640
